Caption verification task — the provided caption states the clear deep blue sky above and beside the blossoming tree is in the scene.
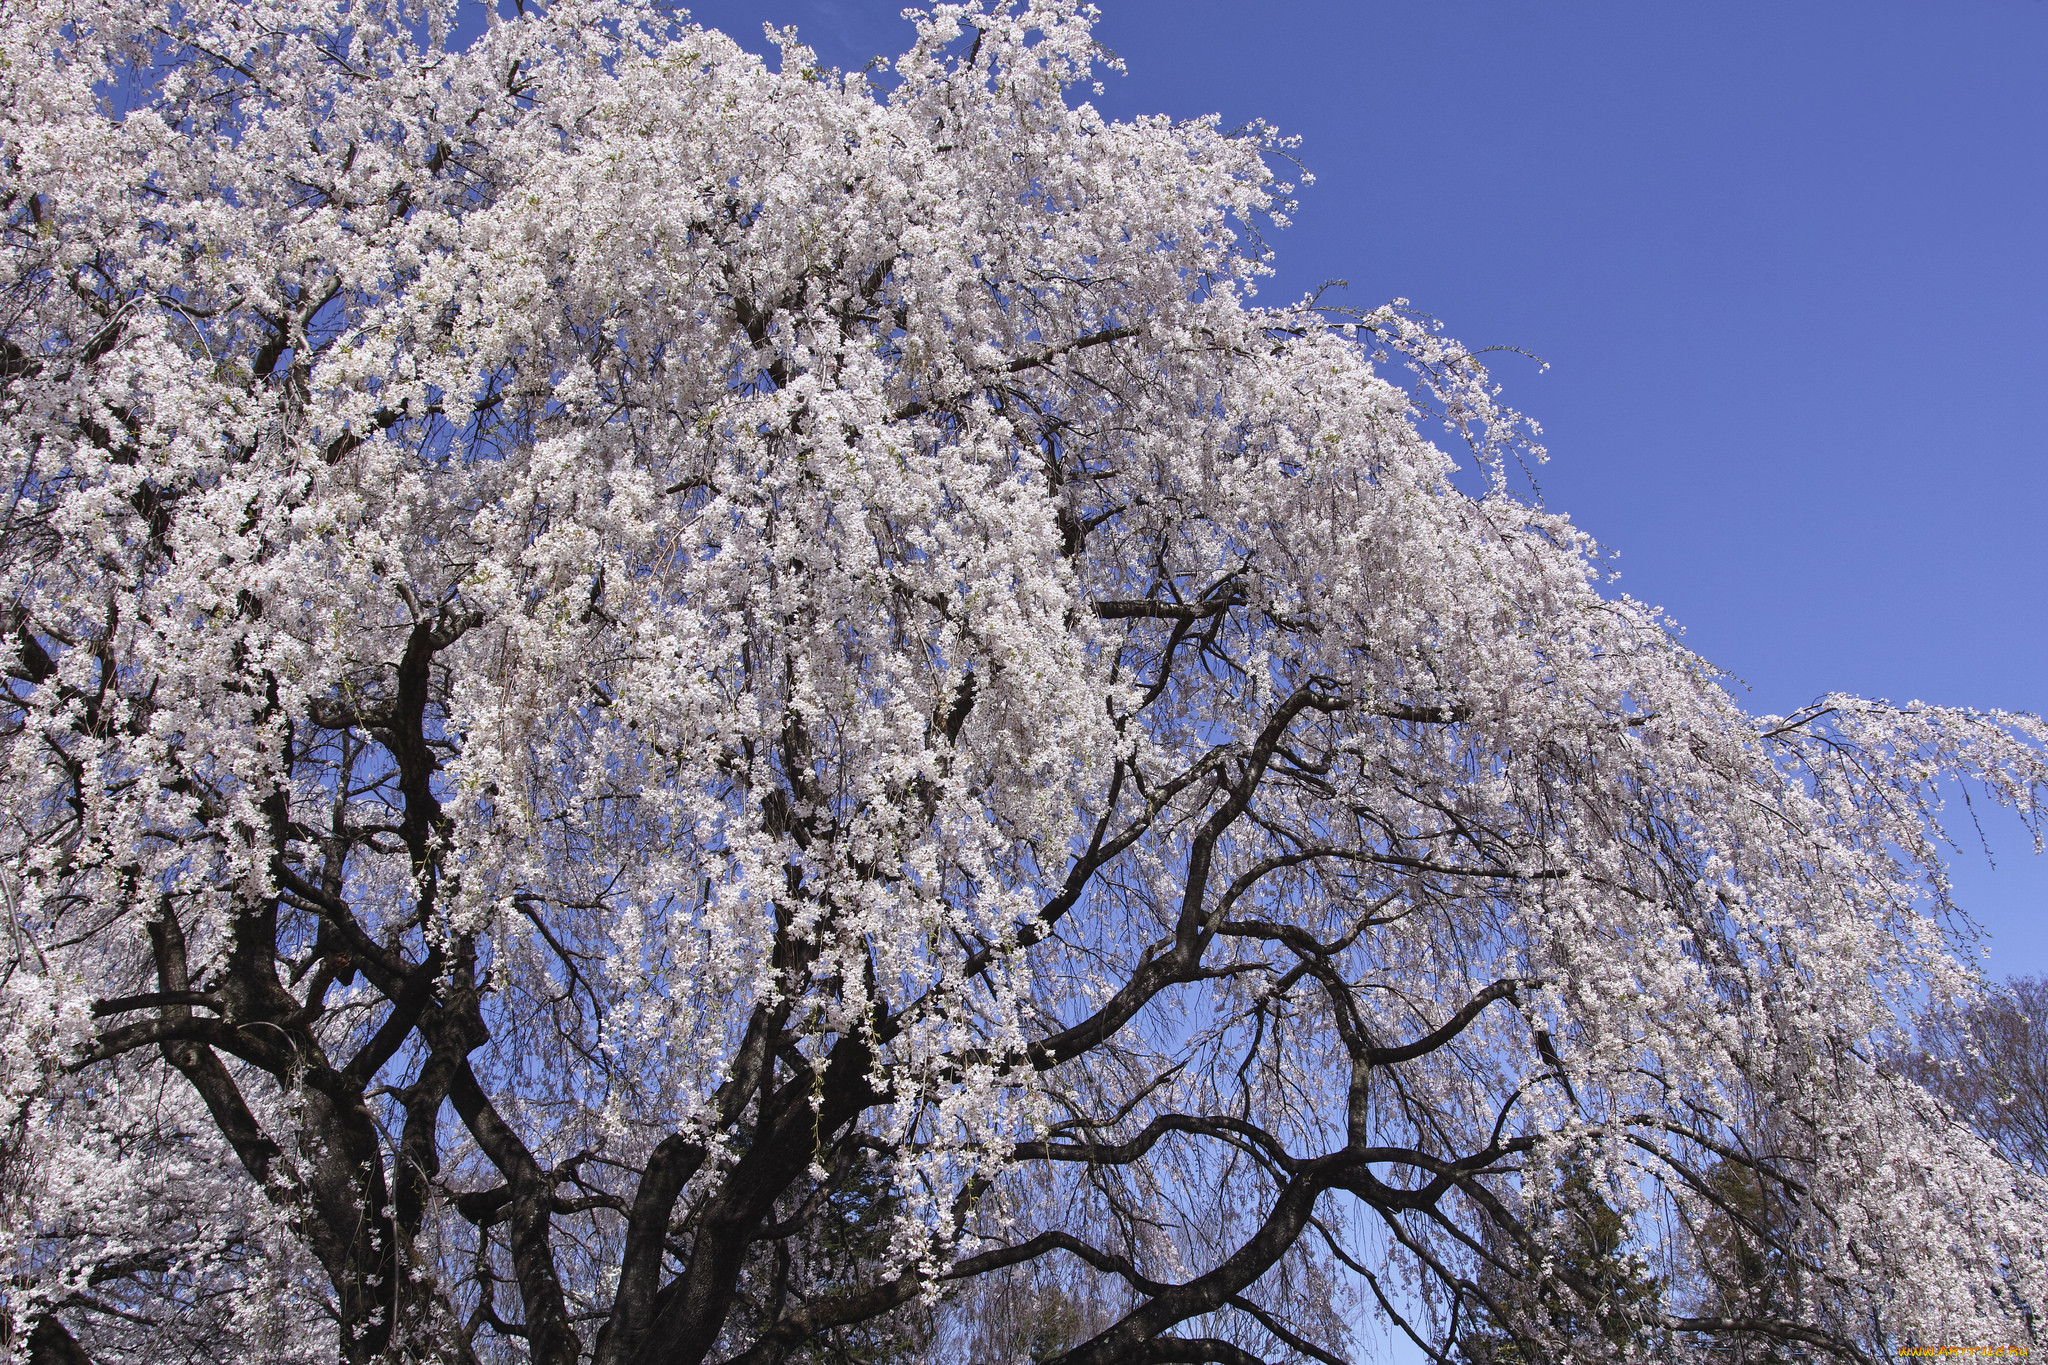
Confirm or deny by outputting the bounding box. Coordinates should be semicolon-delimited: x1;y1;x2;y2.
671;0;2048;976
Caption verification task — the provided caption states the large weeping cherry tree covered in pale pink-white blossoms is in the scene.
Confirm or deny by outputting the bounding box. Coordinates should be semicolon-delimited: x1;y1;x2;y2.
0;0;2048;1365
